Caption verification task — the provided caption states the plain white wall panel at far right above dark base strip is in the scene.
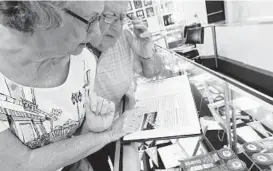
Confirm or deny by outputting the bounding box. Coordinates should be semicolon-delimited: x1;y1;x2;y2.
216;24;273;73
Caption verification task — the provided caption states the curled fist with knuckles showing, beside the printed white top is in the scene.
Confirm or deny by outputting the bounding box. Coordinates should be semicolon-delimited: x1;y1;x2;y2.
82;92;115;132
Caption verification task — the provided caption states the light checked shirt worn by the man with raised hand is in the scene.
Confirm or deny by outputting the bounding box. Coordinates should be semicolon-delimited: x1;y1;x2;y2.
94;34;133;111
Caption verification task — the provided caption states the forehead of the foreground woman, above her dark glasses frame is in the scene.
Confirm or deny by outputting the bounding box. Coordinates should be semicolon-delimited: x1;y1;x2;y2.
66;1;104;17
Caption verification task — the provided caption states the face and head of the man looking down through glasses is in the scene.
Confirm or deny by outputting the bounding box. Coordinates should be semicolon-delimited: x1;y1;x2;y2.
91;1;128;51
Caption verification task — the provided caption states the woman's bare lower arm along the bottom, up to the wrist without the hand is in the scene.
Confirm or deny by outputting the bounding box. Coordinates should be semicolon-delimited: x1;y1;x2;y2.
0;127;111;171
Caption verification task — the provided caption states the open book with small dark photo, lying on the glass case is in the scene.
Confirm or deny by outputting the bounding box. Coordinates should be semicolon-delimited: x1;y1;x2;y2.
123;75;201;141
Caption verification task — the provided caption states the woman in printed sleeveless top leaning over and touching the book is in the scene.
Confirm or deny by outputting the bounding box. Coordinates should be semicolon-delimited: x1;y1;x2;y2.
0;1;144;171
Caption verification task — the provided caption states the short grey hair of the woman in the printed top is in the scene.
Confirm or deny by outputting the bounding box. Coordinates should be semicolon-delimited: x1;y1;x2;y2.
0;1;63;33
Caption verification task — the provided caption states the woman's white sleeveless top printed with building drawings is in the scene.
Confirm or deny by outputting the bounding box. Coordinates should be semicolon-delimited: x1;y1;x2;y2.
0;49;96;149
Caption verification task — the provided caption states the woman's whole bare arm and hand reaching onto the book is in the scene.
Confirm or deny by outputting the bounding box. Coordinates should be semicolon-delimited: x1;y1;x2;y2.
0;105;144;171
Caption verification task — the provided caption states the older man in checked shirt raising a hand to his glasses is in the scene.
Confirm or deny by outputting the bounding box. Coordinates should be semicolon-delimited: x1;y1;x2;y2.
85;1;162;171
